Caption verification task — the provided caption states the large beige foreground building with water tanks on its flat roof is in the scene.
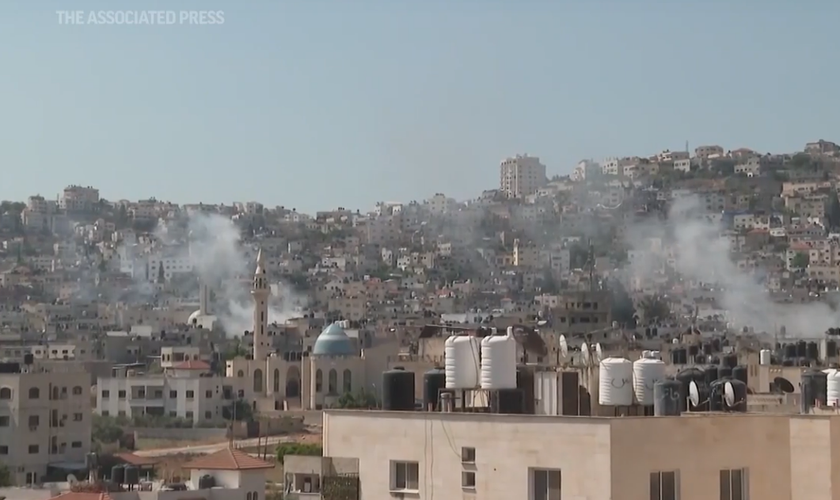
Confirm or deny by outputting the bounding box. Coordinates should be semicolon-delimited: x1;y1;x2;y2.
314;410;840;500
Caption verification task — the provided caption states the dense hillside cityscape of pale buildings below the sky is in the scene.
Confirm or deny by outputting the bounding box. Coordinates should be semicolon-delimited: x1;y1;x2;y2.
0;140;840;500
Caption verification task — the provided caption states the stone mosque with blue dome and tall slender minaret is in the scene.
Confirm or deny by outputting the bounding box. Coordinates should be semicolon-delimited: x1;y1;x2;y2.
225;250;365;411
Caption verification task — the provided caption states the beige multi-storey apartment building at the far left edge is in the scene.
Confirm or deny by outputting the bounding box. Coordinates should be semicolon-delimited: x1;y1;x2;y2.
0;361;91;485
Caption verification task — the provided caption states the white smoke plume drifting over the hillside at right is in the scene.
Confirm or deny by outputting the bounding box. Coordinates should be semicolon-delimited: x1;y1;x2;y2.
624;197;840;337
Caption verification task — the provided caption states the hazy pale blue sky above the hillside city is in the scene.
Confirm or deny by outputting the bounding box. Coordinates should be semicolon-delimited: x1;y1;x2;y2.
0;0;840;211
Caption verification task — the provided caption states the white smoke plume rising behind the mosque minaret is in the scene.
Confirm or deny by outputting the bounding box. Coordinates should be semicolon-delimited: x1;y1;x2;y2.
176;213;304;336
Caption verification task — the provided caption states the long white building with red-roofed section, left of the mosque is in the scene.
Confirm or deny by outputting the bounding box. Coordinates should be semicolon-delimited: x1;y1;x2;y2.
96;360;234;424
